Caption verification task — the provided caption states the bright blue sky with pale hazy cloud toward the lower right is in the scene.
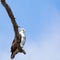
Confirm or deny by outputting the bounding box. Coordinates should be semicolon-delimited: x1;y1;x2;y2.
0;0;60;60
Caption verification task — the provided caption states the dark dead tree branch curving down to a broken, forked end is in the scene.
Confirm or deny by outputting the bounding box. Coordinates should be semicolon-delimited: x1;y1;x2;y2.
1;0;21;59
